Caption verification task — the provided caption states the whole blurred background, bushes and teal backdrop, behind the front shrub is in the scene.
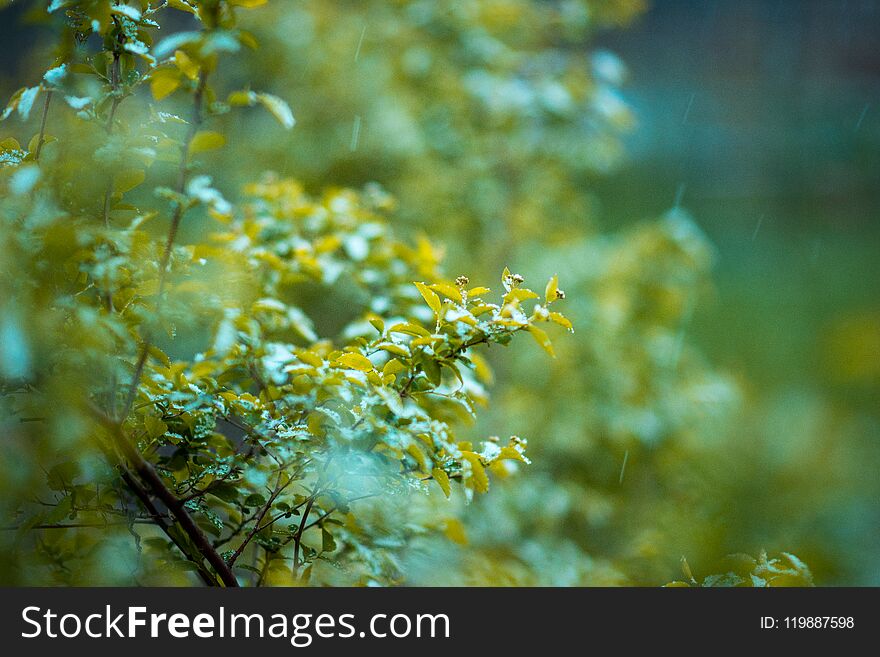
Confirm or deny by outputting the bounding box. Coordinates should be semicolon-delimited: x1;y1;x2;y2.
0;0;880;585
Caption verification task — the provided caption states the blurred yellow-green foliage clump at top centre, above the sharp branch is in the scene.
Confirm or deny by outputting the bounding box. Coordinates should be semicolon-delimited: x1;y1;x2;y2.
222;0;645;249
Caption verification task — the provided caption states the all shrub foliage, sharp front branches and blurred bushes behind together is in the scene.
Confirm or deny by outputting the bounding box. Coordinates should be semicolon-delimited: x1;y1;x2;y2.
0;0;816;585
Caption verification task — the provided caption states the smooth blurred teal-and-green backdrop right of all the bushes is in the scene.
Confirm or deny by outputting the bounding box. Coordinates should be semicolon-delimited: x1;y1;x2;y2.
597;1;880;585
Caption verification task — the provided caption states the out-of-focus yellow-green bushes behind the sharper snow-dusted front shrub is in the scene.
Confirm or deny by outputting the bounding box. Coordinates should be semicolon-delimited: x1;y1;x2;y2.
215;0;824;585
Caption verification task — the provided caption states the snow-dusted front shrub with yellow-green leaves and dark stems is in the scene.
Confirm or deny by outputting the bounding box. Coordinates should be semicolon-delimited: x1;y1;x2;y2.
0;0;571;586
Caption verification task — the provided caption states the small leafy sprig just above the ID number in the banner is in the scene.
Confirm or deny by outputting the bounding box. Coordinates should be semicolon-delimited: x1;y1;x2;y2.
666;551;813;588
